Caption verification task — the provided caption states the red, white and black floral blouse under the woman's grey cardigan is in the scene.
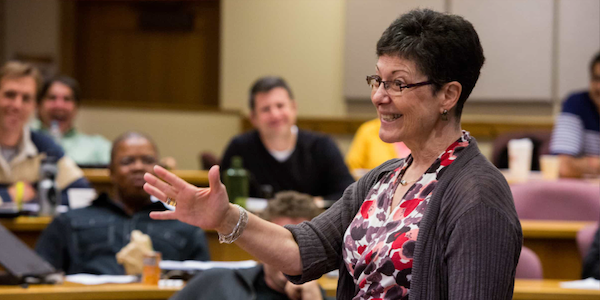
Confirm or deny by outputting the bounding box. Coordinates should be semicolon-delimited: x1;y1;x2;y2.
343;131;470;300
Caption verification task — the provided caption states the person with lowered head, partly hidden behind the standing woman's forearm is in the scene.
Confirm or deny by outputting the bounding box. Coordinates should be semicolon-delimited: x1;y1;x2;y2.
171;191;323;300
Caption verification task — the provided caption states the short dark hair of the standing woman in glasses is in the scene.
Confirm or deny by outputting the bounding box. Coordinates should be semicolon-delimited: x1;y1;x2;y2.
377;9;485;118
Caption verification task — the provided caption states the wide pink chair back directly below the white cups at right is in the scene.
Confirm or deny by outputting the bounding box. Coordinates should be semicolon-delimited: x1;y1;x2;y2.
510;179;600;221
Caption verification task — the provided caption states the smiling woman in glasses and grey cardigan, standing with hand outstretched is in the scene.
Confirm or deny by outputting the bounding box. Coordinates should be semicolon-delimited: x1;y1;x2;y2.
144;9;522;299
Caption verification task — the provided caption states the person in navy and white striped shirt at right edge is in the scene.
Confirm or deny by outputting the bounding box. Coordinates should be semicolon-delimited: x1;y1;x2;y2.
550;52;600;177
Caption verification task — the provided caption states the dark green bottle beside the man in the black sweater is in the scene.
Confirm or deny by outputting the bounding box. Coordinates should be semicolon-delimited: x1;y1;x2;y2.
223;156;249;207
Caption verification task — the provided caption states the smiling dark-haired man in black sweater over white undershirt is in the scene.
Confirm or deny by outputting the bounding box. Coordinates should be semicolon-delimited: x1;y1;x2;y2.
221;77;354;200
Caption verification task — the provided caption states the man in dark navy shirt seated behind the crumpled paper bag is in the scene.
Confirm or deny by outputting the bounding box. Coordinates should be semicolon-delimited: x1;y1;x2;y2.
35;132;210;275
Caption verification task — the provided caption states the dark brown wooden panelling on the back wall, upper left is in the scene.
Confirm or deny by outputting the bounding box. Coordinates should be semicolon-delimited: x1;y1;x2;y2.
76;1;219;109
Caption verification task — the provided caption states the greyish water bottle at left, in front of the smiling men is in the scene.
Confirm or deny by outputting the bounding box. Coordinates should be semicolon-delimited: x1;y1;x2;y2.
38;156;61;216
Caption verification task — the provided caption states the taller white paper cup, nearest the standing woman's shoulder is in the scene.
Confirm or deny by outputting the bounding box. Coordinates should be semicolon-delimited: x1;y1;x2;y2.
508;139;533;182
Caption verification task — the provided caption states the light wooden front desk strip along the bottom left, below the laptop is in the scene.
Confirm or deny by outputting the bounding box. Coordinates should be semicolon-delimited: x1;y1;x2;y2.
0;282;181;300
